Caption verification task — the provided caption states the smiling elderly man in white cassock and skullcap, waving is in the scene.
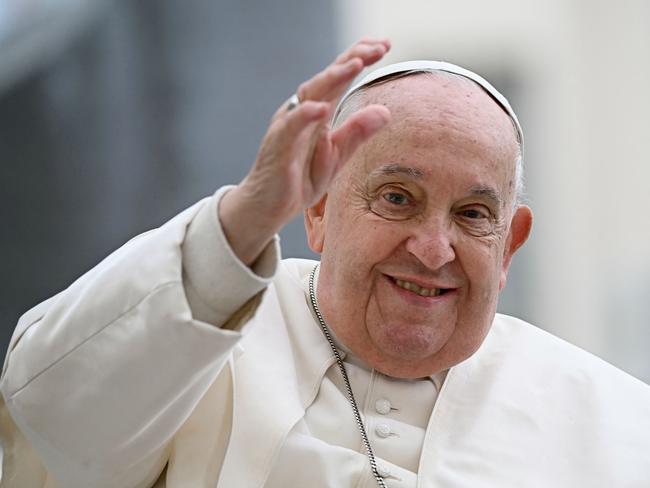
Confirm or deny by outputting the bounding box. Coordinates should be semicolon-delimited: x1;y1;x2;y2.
1;40;650;488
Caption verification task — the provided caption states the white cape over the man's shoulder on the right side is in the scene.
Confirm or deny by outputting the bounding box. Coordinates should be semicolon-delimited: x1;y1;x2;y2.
416;308;650;487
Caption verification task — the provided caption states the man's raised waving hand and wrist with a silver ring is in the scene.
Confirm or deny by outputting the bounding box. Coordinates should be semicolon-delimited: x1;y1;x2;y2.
219;39;390;265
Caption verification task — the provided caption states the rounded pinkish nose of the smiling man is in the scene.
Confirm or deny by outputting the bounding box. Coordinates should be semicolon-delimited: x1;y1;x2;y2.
406;219;456;270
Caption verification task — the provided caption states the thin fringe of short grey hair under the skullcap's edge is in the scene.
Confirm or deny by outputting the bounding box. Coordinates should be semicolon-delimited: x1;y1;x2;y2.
331;69;524;207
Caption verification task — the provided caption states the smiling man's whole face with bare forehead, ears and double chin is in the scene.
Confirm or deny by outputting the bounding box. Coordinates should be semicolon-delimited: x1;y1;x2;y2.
306;75;532;378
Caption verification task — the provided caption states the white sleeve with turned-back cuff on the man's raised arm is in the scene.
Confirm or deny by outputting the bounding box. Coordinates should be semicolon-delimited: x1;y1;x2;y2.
0;188;279;487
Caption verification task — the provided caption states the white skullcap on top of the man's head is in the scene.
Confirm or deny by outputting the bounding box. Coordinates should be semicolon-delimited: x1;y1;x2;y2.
332;60;524;152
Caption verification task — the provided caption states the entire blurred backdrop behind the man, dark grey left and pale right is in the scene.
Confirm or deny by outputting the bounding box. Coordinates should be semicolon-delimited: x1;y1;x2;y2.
0;0;650;382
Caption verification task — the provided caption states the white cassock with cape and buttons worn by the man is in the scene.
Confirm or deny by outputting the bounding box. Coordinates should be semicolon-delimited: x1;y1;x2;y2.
0;190;650;488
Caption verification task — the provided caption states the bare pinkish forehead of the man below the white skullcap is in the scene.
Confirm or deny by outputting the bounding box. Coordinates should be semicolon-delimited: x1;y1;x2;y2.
338;71;521;206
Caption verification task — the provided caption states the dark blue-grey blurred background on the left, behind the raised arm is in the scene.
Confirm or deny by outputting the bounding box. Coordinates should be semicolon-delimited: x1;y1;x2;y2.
0;0;337;344
